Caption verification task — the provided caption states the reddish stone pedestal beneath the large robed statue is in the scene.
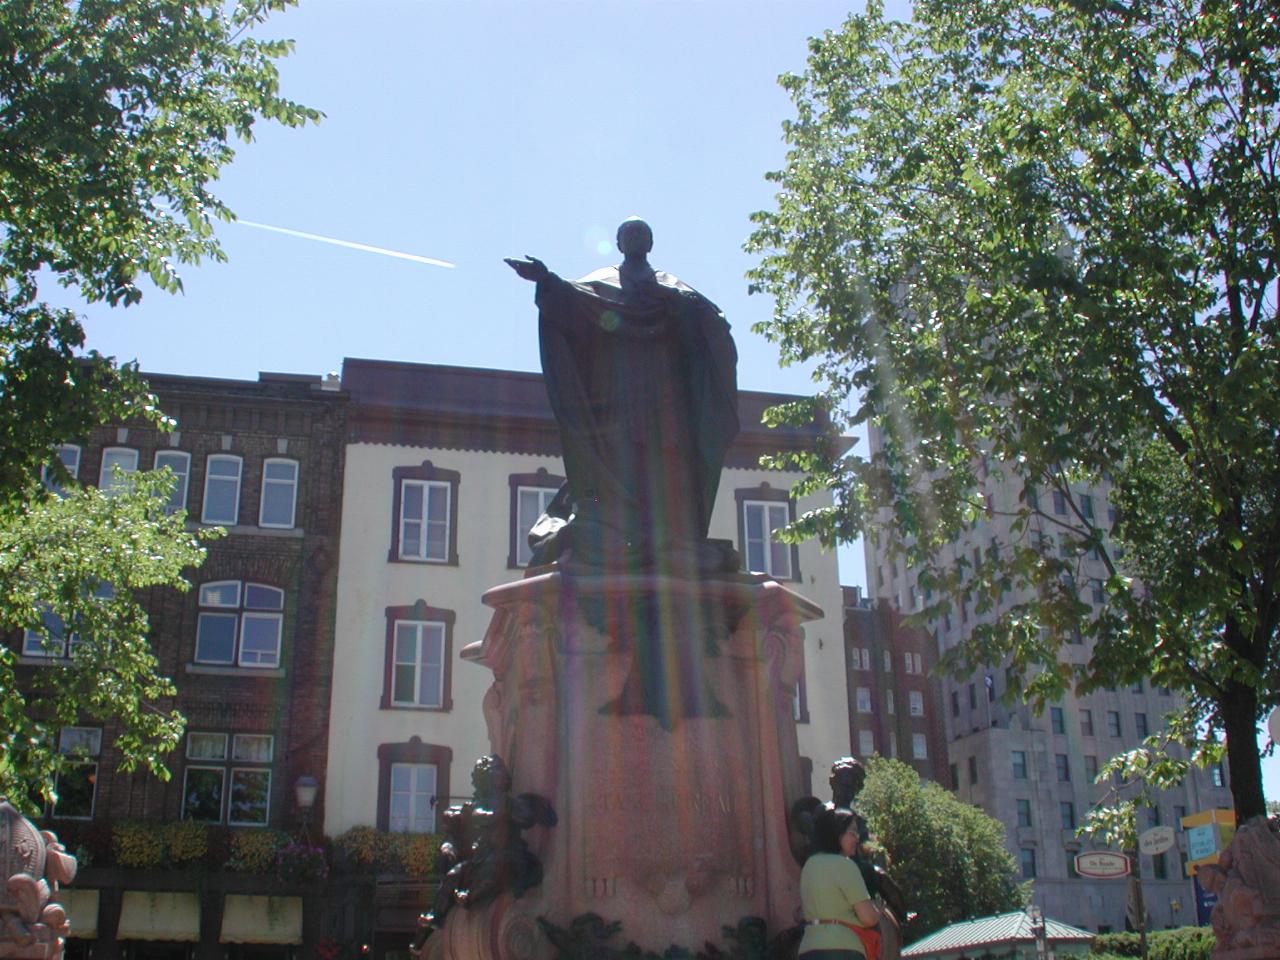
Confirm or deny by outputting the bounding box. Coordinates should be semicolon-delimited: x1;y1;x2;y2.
433;572;822;960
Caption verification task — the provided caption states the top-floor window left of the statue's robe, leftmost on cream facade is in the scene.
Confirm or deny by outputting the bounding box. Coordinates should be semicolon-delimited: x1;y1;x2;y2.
388;461;462;564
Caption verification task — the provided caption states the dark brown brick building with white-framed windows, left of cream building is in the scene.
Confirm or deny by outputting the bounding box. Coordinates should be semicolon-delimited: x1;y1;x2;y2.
14;374;346;960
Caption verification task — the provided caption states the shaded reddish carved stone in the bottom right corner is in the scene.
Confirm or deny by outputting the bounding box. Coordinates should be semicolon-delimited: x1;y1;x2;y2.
1196;817;1280;960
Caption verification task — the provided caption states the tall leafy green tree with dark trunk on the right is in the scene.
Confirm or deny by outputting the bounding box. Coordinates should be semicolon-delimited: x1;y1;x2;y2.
749;0;1280;817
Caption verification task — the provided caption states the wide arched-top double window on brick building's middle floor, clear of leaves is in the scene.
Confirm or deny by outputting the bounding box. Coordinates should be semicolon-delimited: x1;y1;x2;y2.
196;580;284;668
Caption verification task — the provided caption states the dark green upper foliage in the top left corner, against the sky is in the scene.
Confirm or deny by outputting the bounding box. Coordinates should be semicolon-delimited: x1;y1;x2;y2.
0;0;319;498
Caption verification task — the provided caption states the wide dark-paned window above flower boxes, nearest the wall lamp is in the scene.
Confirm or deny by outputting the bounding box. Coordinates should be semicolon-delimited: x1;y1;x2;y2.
182;731;275;827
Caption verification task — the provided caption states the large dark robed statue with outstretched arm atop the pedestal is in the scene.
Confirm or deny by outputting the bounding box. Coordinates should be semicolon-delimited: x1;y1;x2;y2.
506;219;739;573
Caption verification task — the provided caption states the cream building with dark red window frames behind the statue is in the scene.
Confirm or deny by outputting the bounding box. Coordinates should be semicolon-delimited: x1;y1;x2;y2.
324;360;850;836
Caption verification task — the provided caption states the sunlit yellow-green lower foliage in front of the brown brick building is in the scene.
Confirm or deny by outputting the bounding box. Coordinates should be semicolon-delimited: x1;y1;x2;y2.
0;471;209;810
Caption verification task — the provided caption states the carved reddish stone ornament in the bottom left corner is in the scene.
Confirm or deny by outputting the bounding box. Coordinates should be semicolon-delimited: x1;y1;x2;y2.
0;797;76;960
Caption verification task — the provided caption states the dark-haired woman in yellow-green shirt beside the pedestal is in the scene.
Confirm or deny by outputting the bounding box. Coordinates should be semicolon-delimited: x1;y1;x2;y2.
800;806;879;960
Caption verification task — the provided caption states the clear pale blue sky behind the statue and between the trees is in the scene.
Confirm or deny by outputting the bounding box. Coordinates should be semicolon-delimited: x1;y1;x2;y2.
64;0;1280;797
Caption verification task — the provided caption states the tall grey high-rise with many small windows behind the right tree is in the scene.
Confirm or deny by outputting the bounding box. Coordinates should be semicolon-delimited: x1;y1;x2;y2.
867;428;1231;932
